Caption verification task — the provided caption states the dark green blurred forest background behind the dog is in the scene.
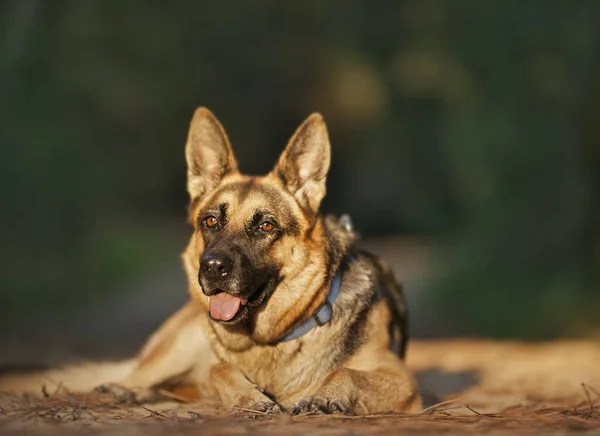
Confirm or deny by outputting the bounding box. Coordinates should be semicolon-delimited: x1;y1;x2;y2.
0;0;600;362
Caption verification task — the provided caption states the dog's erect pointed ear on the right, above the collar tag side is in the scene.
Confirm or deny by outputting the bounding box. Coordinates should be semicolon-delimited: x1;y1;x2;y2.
273;113;331;213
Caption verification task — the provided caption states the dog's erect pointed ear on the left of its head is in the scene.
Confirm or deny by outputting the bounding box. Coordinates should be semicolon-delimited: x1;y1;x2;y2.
185;107;237;201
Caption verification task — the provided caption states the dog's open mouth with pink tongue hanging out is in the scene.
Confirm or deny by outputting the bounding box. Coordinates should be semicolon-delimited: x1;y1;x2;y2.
208;282;272;323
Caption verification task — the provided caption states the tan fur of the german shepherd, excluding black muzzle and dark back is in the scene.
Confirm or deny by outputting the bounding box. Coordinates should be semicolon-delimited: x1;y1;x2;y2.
0;108;420;413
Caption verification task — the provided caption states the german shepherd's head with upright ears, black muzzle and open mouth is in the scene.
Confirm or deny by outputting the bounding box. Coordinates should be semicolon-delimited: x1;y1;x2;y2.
184;108;330;330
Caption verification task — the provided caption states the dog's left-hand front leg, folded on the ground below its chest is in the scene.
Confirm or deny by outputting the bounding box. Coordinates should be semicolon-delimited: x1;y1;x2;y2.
209;363;281;413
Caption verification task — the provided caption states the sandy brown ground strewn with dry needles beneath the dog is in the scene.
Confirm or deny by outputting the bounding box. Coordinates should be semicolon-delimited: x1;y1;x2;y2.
0;340;600;435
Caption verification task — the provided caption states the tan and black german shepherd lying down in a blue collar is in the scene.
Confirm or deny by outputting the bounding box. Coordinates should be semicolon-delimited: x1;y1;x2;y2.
0;108;421;414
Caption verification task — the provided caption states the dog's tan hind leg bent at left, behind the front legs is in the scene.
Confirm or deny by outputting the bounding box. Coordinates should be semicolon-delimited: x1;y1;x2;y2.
101;301;210;401
